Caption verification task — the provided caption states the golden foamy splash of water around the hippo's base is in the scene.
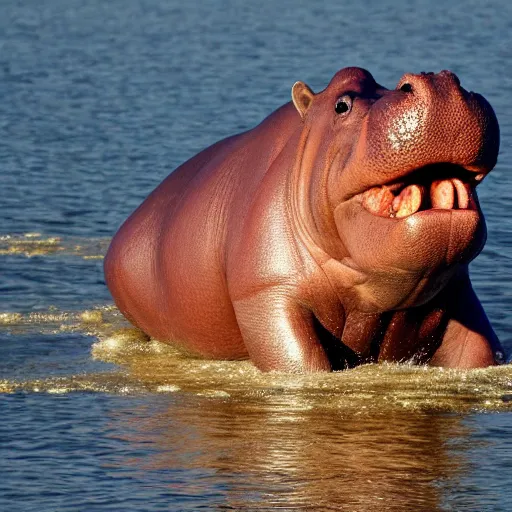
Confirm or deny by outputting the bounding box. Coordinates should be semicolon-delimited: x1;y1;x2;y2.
0;306;512;414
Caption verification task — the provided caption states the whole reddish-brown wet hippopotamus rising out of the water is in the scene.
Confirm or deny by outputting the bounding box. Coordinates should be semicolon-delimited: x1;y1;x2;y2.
105;67;503;373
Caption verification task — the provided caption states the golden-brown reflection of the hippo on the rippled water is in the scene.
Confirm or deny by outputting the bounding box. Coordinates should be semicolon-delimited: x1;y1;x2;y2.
102;384;482;512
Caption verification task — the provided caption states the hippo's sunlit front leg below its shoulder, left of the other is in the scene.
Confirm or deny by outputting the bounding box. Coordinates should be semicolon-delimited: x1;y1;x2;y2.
234;288;332;373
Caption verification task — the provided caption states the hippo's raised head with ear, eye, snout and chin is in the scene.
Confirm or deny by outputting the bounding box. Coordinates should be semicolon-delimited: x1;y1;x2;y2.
292;68;499;311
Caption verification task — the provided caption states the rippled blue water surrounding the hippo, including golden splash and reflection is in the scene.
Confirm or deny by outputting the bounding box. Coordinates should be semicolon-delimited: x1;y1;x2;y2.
0;0;512;512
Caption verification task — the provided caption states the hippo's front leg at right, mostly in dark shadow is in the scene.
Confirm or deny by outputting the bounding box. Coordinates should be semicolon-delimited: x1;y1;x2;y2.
431;270;504;368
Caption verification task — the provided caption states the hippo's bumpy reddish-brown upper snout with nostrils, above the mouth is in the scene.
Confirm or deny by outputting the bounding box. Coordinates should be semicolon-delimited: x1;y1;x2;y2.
365;71;499;178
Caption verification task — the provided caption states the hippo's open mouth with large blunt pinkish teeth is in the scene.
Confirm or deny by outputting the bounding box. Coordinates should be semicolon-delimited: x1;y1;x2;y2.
361;163;481;219
